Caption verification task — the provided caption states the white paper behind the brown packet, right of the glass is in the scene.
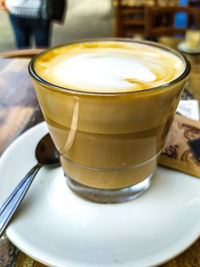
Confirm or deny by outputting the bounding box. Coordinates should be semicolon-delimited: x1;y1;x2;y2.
176;99;199;121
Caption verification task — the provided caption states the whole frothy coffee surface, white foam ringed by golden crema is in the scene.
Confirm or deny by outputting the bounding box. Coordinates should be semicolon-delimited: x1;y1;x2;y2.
34;41;185;93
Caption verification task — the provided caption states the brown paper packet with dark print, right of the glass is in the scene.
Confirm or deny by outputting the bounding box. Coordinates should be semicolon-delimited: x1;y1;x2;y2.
158;114;200;177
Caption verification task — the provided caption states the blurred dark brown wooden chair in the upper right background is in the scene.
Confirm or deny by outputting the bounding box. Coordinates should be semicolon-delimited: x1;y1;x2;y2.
145;6;200;39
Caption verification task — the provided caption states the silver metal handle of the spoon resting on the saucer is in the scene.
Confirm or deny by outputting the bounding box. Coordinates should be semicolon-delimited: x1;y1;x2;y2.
0;163;42;237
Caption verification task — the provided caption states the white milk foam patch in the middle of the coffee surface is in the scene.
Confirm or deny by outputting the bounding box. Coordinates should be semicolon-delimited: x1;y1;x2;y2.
52;53;156;91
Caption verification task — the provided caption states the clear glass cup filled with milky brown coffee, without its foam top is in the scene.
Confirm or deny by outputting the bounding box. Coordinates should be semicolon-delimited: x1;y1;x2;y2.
29;39;190;203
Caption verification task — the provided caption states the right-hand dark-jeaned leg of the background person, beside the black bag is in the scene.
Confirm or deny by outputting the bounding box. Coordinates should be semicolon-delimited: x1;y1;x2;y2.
32;20;51;47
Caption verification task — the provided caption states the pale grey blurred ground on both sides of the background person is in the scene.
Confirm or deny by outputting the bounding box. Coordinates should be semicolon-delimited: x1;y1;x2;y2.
0;0;112;51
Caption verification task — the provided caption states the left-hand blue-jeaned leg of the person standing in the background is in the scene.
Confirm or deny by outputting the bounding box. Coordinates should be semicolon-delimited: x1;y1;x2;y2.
10;14;30;49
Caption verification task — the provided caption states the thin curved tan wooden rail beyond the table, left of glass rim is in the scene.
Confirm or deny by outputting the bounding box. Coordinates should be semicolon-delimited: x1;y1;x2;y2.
0;48;44;58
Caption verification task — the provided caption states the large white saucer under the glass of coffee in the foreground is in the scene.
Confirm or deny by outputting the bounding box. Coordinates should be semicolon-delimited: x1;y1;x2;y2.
0;123;200;267
